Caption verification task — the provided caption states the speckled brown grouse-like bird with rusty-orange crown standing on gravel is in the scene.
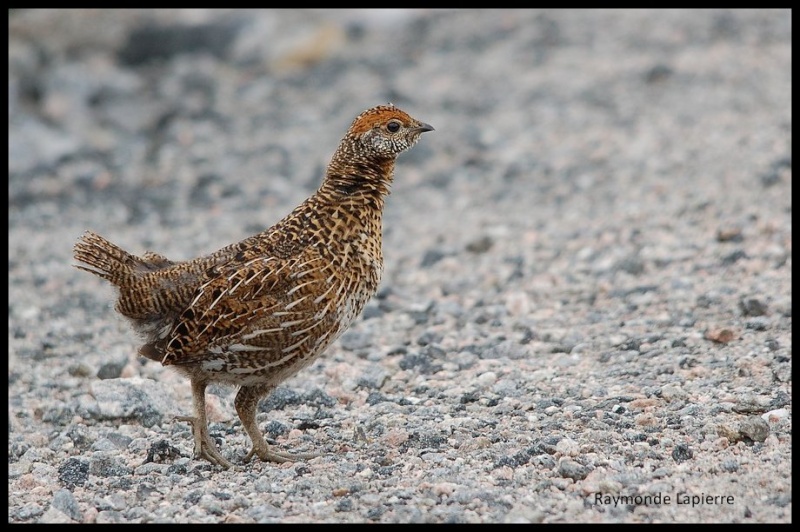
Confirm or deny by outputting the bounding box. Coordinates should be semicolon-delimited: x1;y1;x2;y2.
73;104;434;469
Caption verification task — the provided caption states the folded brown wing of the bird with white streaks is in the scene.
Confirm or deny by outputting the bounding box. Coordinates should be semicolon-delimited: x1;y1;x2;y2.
162;248;325;365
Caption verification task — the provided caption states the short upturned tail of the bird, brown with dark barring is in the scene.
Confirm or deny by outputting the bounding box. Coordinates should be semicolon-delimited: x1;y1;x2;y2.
73;231;140;286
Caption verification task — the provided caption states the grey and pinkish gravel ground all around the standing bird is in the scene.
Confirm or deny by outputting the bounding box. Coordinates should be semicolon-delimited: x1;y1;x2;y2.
8;10;792;523
